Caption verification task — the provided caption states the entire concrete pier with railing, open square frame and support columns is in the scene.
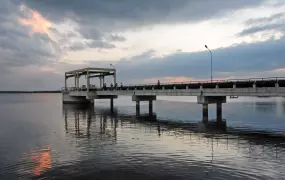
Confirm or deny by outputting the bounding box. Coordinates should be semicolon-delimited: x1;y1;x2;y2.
62;68;285;121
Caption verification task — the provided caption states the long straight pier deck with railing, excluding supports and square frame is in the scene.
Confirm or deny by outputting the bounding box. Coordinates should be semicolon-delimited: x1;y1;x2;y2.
67;78;285;97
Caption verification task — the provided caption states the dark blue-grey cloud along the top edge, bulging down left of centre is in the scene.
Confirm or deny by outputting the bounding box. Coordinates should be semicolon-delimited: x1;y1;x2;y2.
17;0;263;40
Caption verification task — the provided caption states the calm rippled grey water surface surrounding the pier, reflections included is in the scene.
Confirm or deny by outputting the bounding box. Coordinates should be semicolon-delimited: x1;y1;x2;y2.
0;94;285;180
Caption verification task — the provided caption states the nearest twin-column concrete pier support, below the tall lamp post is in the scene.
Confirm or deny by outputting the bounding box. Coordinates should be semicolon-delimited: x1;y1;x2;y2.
197;96;227;121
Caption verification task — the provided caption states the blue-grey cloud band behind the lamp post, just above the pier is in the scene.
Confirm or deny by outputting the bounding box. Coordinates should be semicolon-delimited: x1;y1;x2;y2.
103;38;285;79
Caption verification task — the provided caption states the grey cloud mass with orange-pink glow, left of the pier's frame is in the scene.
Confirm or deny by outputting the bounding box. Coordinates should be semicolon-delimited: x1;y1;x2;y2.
0;0;61;90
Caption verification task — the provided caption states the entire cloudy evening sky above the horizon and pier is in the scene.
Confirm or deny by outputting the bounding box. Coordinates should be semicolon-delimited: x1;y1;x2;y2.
0;0;285;90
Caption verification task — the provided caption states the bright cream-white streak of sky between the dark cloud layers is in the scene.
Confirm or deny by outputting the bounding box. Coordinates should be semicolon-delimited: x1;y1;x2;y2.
58;1;285;61
